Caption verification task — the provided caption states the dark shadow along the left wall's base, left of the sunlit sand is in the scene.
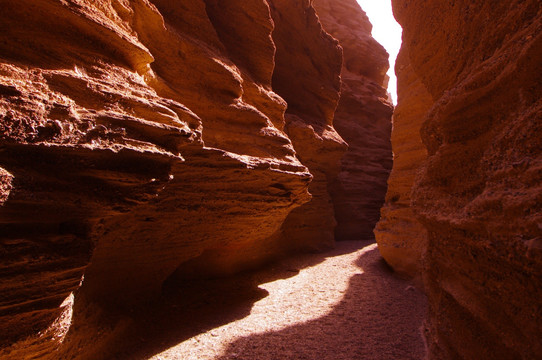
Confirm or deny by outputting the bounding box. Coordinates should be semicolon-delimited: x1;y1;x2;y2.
57;241;371;360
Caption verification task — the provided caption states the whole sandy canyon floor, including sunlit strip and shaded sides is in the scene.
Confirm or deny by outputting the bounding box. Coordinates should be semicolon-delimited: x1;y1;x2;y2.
138;241;432;360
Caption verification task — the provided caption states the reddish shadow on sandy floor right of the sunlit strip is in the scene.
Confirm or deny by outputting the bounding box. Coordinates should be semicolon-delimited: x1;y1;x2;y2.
217;247;432;360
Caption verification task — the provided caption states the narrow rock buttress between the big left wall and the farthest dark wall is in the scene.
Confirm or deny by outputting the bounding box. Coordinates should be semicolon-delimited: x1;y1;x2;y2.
269;0;347;250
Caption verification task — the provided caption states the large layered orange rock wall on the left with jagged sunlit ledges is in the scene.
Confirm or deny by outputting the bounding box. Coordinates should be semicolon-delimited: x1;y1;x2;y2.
0;1;311;343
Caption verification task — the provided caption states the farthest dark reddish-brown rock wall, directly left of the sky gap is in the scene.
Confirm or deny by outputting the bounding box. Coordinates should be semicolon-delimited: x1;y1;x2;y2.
313;0;393;240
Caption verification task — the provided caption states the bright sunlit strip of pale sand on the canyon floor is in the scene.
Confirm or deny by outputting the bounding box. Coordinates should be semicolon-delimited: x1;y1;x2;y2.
151;243;382;360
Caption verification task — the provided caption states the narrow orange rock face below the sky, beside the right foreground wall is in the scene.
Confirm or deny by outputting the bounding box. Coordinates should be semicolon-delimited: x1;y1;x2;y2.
375;47;432;279
